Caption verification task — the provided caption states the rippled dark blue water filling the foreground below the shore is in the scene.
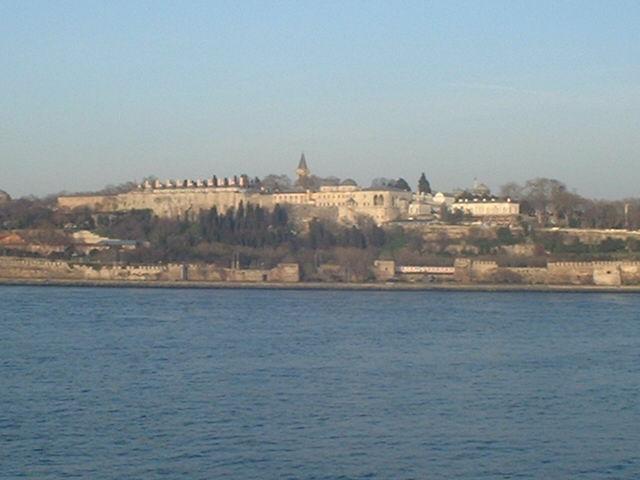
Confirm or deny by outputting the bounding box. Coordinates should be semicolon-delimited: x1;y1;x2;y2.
0;287;640;479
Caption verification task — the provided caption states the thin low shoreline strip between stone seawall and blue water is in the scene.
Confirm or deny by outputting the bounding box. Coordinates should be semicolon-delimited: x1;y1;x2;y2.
0;278;640;293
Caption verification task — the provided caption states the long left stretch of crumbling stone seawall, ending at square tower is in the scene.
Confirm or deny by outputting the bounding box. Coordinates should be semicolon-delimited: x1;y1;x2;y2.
0;257;300;283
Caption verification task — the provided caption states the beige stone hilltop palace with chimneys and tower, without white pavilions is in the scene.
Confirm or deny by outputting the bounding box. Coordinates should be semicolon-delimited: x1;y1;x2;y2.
58;155;412;224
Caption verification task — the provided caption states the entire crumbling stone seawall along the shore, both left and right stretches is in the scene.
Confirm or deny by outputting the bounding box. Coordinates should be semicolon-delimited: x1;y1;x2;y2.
0;257;640;287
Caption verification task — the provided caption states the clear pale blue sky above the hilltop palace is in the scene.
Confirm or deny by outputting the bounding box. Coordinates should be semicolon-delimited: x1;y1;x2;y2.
0;0;640;198
